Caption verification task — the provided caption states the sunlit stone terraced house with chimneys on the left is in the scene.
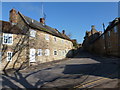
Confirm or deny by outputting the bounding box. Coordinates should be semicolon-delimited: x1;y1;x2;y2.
0;9;73;70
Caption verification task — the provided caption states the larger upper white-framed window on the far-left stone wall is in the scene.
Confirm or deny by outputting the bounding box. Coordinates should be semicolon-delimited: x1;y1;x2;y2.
3;33;13;45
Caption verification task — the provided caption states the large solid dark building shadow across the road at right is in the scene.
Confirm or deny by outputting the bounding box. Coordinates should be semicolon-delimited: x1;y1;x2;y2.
63;48;120;79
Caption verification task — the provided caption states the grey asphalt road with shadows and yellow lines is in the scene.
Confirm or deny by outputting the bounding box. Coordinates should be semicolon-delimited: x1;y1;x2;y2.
2;51;120;88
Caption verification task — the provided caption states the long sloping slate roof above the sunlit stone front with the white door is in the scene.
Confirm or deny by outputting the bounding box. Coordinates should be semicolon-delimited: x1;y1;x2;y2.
18;12;71;41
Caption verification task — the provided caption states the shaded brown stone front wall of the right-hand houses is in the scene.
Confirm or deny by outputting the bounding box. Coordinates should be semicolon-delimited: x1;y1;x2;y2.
83;23;120;57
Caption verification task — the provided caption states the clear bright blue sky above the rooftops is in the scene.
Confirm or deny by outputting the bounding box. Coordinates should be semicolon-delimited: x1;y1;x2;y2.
2;2;118;43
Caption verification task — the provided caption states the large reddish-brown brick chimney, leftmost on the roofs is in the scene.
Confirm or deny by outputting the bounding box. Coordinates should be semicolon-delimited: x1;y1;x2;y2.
9;9;17;24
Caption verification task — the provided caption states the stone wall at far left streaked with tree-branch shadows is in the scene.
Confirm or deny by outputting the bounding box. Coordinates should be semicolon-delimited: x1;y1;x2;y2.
1;34;28;70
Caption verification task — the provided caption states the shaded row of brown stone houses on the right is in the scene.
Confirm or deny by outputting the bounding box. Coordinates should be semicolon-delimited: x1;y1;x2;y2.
83;18;120;57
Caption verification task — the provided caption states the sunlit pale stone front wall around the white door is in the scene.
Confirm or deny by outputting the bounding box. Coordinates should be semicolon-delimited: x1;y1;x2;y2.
29;30;73;63
